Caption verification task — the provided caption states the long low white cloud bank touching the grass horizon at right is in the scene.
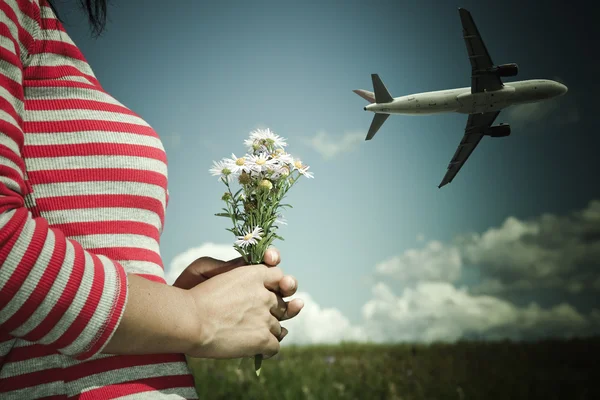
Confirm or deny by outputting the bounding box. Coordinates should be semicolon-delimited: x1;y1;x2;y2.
363;282;600;342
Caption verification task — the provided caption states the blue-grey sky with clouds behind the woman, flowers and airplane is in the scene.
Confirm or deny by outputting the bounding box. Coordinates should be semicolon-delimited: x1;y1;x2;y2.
58;0;600;344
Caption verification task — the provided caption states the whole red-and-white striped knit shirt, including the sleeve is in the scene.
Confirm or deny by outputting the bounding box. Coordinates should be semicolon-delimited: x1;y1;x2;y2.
0;0;197;399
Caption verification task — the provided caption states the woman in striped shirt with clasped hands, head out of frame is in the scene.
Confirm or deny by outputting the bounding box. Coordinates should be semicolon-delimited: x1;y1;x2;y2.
0;0;302;399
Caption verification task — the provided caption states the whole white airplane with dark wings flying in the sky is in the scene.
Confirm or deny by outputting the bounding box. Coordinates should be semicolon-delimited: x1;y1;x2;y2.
353;8;568;188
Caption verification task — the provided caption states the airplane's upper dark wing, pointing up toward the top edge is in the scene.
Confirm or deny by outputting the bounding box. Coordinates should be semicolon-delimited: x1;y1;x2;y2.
458;8;504;93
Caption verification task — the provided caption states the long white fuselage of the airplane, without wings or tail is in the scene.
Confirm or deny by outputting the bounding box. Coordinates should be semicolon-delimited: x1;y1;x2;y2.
365;79;567;115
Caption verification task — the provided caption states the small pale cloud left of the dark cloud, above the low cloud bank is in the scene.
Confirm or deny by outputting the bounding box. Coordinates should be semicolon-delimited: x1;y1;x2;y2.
375;240;462;284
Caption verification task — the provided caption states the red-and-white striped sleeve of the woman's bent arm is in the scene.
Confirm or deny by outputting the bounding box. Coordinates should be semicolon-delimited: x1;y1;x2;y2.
0;0;128;360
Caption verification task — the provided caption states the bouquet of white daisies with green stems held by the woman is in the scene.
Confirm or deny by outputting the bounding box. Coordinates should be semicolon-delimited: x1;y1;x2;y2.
210;129;313;374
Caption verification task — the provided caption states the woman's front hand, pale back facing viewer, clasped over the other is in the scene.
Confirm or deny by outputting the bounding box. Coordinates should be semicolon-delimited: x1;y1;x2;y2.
186;264;302;358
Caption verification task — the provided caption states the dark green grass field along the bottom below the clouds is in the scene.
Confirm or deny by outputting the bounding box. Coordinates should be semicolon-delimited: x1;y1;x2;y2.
189;338;600;400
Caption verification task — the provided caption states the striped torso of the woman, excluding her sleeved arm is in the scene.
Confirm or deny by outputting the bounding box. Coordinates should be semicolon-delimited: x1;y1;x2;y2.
0;0;197;399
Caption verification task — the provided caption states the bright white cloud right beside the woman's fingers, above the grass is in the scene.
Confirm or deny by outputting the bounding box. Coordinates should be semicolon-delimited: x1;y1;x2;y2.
281;293;366;345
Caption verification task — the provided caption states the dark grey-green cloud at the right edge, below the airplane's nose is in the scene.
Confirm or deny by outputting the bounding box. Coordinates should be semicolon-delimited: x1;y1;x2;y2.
457;200;600;293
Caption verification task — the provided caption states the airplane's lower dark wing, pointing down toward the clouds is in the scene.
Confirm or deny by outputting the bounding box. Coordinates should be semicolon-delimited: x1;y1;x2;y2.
438;111;500;188
